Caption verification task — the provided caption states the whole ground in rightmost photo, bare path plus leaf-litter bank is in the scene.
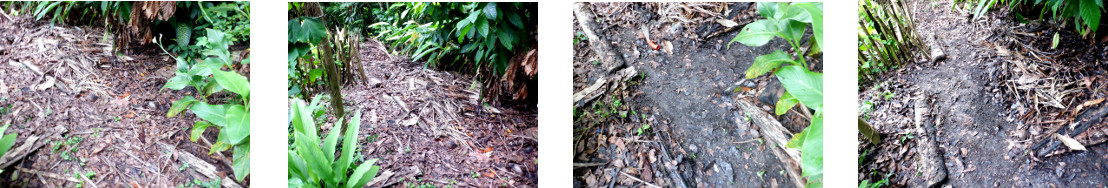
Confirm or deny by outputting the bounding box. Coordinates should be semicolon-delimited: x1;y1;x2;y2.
858;1;1108;187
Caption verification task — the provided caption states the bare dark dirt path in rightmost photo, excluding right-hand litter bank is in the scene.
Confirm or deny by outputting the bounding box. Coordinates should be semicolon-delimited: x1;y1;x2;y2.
859;1;1108;187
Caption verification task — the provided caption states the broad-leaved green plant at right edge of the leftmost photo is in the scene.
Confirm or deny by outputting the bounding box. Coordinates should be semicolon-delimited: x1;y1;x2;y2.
162;29;250;180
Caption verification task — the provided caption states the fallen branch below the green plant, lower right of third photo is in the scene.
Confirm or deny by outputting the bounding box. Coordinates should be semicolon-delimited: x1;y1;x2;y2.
736;100;806;187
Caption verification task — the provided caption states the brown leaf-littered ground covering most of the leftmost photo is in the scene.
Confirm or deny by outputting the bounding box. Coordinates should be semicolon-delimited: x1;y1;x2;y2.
0;17;249;187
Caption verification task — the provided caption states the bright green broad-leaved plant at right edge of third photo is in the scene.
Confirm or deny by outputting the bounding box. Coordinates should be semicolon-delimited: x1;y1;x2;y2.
731;2;823;187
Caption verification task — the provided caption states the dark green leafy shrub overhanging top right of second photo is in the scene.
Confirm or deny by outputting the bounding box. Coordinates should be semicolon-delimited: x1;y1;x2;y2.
368;2;538;98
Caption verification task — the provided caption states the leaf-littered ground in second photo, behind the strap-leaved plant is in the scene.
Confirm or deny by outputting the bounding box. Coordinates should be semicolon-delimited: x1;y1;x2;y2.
310;38;538;187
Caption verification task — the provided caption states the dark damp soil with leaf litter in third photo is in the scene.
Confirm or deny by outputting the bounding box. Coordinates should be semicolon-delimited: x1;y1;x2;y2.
574;3;808;187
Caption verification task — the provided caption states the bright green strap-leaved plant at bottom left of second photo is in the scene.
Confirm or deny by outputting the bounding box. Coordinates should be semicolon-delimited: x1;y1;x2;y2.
288;98;380;188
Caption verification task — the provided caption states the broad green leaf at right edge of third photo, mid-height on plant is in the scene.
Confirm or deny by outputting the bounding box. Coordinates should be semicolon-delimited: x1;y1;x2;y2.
776;65;823;111
